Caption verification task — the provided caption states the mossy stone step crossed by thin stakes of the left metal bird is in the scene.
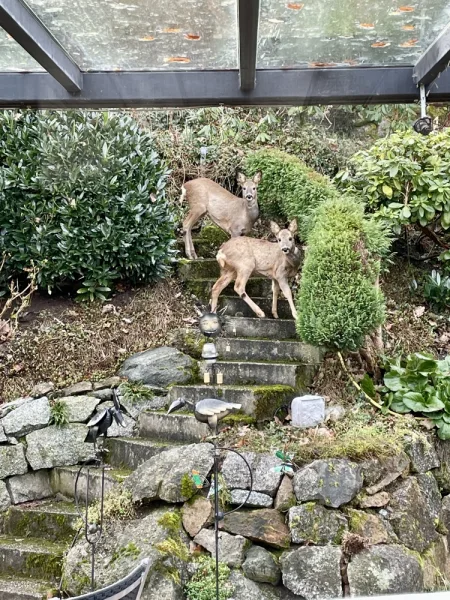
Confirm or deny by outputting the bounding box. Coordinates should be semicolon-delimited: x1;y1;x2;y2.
50;466;131;502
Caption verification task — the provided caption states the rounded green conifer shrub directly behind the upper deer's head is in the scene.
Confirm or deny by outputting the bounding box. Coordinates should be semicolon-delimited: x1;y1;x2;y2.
245;149;338;239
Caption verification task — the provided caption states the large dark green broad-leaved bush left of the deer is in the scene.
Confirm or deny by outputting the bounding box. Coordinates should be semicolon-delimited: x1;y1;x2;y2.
0;111;173;299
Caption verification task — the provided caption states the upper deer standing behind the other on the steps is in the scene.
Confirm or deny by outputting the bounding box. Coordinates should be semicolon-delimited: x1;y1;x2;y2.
181;173;261;259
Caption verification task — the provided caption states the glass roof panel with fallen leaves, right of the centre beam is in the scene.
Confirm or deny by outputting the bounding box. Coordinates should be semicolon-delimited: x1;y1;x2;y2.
257;0;450;69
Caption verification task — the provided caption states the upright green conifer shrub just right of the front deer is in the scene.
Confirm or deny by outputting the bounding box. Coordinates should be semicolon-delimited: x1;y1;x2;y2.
297;197;388;350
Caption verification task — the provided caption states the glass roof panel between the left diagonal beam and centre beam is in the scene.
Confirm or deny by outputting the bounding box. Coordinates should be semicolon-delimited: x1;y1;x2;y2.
27;0;238;71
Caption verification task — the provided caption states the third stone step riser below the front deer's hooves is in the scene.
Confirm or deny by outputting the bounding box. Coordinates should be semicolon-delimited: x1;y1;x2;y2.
204;360;316;391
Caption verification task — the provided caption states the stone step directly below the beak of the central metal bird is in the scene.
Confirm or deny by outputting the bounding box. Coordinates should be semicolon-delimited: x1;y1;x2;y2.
139;411;211;444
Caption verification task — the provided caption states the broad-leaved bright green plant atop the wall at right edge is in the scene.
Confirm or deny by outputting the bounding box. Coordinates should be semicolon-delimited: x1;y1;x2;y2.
379;352;450;440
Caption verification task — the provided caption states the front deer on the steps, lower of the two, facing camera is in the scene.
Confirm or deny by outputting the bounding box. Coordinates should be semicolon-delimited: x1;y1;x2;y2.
211;219;301;319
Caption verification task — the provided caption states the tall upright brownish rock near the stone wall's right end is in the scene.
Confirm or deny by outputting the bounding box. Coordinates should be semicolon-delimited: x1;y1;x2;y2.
389;477;437;552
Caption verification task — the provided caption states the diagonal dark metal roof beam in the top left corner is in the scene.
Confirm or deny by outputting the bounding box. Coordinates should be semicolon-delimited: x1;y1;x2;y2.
0;0;83;93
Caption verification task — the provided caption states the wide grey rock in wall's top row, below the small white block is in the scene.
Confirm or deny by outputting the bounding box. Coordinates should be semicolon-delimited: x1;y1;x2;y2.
294;458;363;508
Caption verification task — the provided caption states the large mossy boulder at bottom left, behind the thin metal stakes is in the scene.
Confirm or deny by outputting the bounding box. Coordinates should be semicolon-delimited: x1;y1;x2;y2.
63;508;188;600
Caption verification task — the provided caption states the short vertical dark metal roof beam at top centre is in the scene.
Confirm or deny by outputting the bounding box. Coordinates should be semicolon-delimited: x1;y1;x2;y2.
238;0;259;92
